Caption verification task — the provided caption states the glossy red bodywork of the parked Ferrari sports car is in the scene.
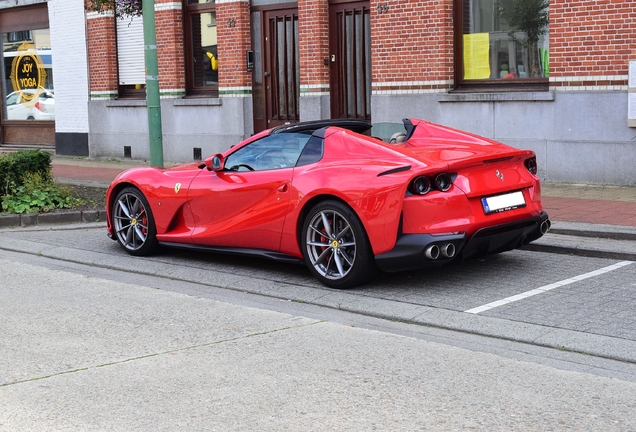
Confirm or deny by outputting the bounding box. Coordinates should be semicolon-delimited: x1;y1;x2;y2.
106;119;542;268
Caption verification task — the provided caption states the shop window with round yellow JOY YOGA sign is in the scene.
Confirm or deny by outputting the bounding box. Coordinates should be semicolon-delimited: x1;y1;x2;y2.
2;29;55;121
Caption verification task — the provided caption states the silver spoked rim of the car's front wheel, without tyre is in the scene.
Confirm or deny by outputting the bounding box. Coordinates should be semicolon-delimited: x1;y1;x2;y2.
113;192;148;251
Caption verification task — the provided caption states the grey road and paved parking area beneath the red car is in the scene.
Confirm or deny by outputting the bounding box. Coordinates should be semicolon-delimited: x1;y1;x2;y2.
0;224;636;431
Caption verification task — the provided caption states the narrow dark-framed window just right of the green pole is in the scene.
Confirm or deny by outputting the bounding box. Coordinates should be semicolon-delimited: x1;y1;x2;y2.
184;0;219;96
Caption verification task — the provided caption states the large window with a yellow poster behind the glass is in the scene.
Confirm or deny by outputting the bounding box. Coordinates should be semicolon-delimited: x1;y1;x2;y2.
455;0;550;90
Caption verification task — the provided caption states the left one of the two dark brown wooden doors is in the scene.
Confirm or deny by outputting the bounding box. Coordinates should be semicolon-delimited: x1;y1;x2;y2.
252;9;300;132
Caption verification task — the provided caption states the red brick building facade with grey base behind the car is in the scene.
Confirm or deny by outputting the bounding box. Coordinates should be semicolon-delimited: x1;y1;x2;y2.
0;0;636;185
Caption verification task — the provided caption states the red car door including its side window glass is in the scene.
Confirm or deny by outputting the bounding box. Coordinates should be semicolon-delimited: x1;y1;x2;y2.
188;133;309;251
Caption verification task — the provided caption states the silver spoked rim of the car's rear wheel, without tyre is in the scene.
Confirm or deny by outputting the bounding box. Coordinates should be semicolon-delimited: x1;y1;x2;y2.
305;210;356;280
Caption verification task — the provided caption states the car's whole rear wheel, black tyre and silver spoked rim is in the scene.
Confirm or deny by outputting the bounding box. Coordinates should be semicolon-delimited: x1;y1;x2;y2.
302;200;376;288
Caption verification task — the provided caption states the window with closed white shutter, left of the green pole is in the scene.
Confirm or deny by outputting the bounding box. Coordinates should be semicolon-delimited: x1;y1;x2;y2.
117;9;146;99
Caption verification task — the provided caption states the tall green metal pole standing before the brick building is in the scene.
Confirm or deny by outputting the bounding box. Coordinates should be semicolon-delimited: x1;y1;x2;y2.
141;0;163;167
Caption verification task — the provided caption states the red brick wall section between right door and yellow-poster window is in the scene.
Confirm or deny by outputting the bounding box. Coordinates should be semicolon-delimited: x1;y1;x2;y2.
370;0;454;89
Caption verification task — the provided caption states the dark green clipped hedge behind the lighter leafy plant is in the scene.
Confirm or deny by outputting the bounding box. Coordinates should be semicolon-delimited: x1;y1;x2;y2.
0;150;51;195
